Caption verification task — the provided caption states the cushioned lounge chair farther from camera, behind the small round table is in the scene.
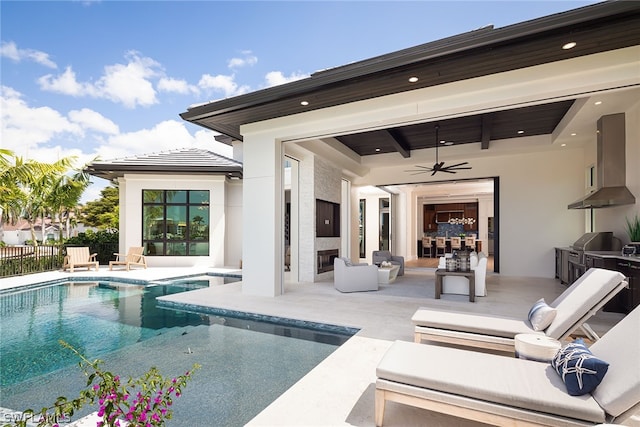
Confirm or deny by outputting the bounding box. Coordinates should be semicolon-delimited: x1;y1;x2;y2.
411;268;628;352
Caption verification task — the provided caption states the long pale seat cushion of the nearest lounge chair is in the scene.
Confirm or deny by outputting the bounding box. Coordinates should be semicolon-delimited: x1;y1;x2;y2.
376;341;605;423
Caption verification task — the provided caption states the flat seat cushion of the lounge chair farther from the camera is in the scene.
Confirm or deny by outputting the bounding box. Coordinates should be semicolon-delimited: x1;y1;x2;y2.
411;308;536;338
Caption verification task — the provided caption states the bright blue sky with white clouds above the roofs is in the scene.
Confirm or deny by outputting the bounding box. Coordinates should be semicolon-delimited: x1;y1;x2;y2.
0;0;595;201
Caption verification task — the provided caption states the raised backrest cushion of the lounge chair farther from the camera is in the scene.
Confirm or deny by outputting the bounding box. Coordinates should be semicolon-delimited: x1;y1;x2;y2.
544;268;624;339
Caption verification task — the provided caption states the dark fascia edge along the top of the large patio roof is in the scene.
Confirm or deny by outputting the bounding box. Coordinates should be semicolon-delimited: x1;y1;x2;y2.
180;1;640;125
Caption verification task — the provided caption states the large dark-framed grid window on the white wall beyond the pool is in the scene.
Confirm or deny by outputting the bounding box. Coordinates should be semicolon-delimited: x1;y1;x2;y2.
142;190;209;256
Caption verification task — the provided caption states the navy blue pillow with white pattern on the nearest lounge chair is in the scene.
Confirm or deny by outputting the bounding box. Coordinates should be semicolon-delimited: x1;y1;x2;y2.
551;338;609;396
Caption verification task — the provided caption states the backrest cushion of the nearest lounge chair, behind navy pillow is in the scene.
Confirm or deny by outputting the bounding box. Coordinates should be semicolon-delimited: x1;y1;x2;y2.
589;306;640;417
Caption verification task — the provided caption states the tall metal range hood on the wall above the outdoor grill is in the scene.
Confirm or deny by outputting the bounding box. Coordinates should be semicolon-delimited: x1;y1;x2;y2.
569;113;636;209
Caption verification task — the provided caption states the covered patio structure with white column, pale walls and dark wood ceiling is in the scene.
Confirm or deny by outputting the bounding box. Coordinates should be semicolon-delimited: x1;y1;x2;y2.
181;2;640;296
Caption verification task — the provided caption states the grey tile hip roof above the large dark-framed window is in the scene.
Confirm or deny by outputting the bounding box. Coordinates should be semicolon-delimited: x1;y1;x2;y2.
85;148;242;180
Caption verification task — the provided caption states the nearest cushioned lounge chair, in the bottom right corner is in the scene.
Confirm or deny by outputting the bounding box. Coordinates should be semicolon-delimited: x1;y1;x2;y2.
375;307;640;426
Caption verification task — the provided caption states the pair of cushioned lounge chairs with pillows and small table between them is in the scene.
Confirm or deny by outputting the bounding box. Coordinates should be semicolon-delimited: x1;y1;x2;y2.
375;268;640;426
